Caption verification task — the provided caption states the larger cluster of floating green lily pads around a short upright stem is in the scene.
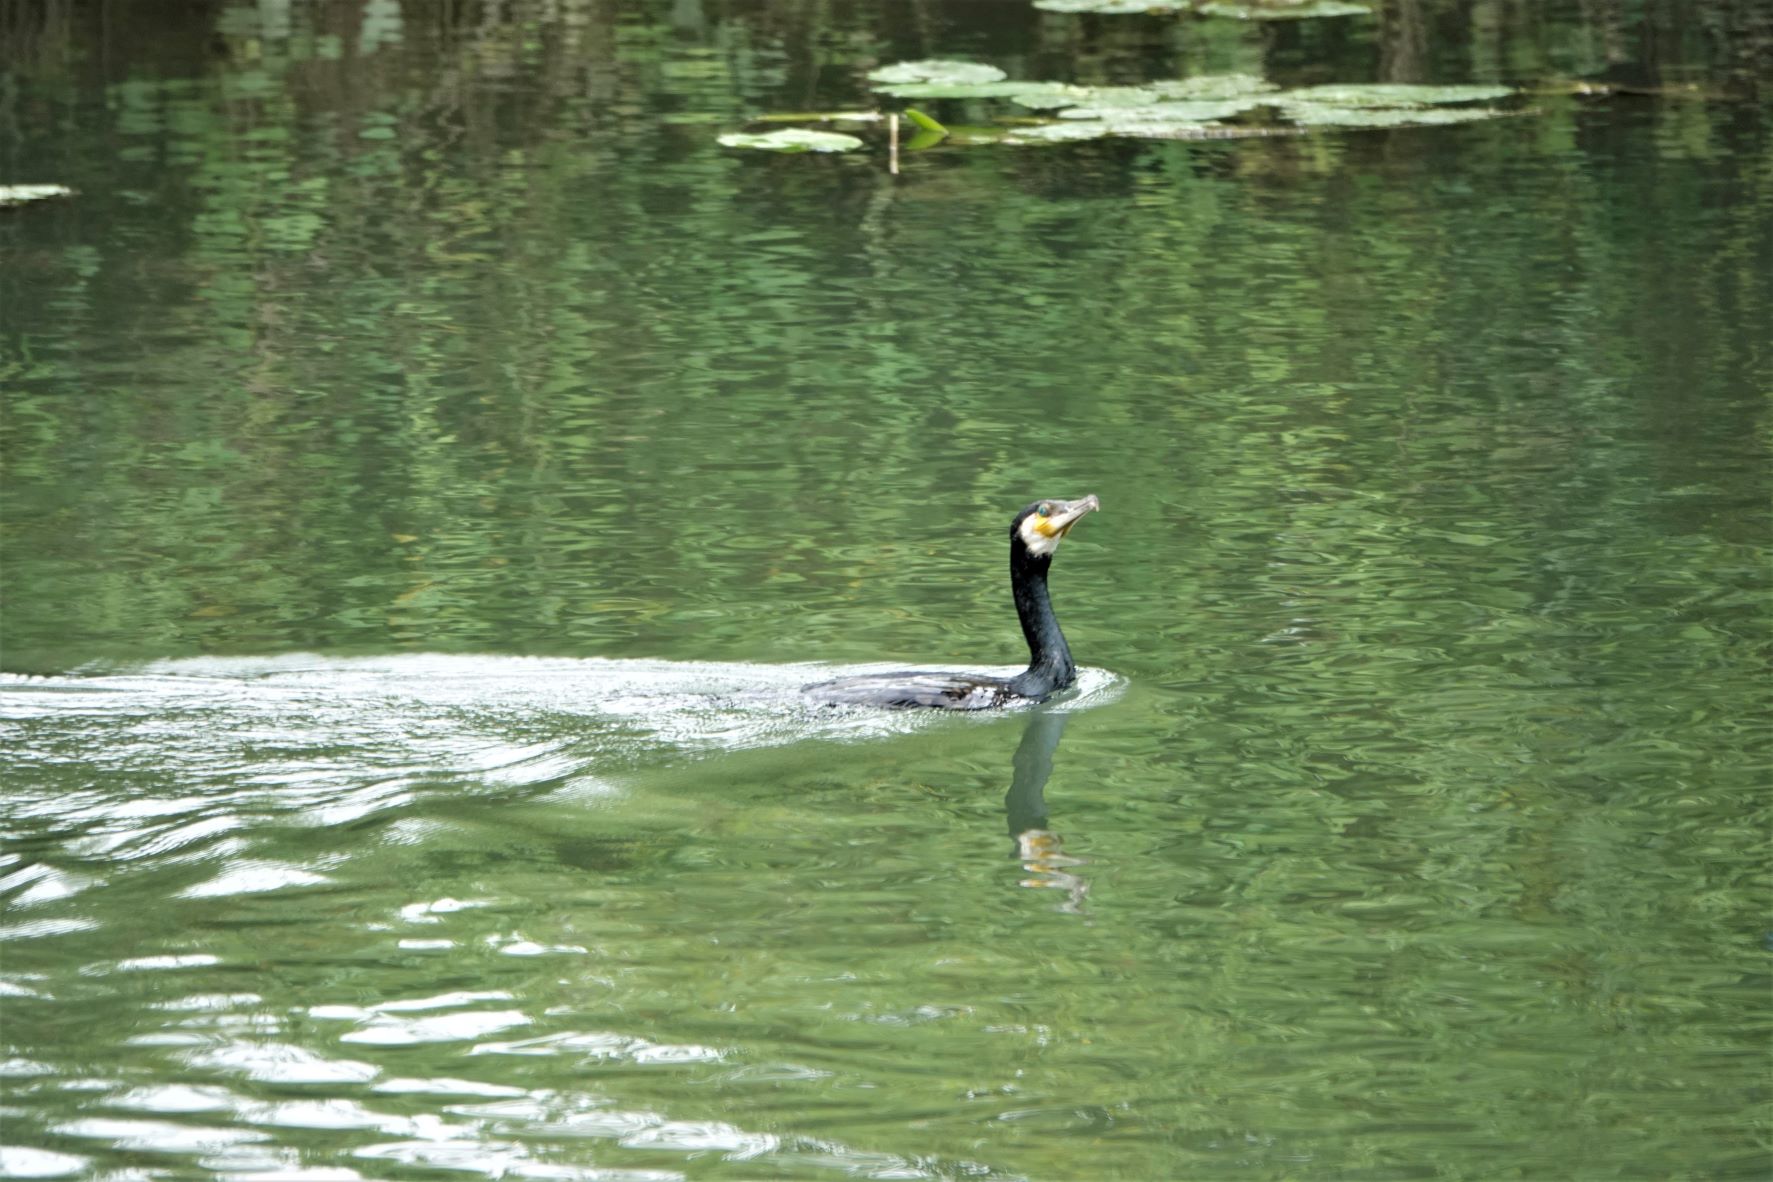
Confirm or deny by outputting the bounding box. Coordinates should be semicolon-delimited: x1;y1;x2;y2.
720;60;1516;152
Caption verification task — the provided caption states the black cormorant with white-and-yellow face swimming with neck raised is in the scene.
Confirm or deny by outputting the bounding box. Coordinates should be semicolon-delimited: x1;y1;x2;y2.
805;494;1101;711
